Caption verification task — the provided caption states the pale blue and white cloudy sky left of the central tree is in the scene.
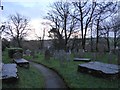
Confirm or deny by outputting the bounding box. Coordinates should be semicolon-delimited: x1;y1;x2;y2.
0;0;55;39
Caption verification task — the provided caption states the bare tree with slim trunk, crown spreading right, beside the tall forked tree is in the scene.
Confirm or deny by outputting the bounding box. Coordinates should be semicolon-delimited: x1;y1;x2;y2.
92;2;116;51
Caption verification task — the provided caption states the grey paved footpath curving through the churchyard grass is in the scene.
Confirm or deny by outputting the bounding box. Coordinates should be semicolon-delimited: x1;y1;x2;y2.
30;62;67;90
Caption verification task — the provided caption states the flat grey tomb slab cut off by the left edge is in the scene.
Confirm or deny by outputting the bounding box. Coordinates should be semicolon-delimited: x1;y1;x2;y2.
0;64;18;80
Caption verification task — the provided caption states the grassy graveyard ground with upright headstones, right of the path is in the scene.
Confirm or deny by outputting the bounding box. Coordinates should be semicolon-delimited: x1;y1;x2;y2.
23;50;120;88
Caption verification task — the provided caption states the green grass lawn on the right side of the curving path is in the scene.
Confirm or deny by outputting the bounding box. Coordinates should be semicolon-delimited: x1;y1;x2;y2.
26;53;120;88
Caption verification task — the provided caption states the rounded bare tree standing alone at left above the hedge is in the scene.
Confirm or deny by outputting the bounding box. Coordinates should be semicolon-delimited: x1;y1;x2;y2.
5;13;30;47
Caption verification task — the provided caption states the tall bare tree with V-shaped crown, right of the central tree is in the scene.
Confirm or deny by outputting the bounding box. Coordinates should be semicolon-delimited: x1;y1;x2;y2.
72;0;96;50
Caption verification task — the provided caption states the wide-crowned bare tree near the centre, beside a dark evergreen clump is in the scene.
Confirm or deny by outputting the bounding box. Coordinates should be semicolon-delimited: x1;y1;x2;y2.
45;2;77;49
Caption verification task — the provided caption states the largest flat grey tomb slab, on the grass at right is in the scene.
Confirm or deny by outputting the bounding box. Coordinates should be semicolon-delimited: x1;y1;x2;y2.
78;62;120;77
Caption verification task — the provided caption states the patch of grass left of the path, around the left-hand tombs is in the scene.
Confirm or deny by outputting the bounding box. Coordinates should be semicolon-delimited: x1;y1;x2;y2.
2;52;44;88
